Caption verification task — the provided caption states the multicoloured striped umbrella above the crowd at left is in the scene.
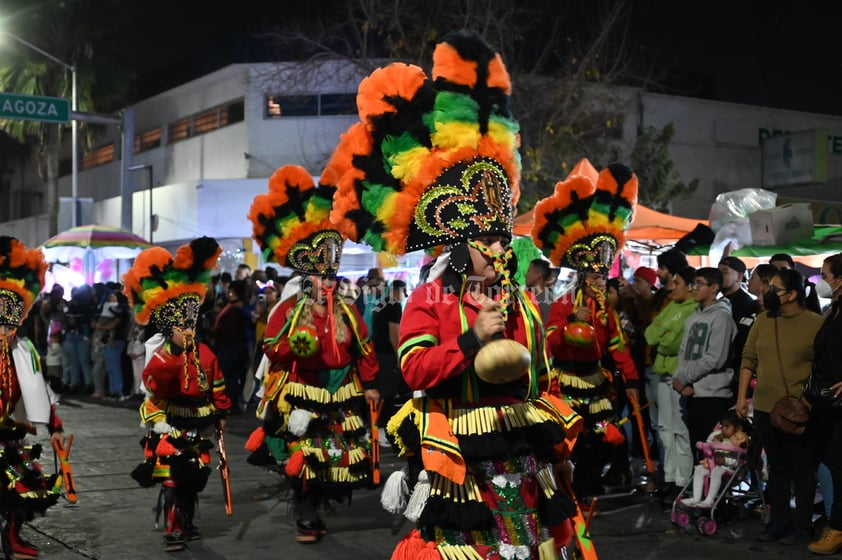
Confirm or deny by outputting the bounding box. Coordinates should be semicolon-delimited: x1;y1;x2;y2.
41;224;153;284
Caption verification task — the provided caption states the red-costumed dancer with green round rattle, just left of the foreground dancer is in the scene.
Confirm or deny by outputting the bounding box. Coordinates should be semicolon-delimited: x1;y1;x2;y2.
246;165;380;544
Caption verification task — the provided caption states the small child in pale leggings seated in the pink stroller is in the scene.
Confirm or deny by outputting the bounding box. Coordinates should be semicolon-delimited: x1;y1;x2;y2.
679;410;749;509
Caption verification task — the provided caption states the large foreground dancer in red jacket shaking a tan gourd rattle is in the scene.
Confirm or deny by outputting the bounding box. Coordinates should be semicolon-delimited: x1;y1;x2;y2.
321;32;581;560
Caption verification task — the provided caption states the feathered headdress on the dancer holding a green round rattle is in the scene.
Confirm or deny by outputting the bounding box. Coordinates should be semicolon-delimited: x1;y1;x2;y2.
248;165;344;276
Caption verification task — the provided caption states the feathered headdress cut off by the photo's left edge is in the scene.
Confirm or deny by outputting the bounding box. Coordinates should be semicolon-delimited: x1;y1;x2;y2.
0;235;47;328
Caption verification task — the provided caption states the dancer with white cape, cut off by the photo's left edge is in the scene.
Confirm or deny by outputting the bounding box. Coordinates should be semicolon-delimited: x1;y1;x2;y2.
0;236;63;558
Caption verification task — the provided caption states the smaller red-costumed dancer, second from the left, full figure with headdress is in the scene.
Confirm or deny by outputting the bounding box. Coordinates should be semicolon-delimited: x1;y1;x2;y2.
123;237;231;551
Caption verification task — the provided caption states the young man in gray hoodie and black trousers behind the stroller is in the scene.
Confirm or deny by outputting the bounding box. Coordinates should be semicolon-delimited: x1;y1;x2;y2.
673;268;737;456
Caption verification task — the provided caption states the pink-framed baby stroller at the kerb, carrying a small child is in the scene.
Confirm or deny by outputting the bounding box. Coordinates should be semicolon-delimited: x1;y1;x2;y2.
670;422;769;536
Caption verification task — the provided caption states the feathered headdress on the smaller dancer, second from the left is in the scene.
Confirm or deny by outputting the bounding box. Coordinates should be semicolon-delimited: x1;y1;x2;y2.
123;237;222;331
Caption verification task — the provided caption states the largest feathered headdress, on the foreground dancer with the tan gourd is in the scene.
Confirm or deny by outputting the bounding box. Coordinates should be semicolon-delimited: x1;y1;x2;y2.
319;32;520;255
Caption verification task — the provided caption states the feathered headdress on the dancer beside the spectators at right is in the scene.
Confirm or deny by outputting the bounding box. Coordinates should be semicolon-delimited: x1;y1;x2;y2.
532;159;637;273
